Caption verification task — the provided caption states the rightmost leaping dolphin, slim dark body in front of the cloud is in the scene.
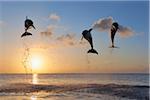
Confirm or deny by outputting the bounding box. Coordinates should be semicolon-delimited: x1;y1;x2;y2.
111;22;119;48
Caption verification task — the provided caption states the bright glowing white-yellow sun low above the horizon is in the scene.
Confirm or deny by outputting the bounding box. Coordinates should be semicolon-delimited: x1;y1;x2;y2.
31;55;43;70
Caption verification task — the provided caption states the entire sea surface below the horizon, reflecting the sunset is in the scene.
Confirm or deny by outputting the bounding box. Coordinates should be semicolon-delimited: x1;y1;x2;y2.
0;73;150;100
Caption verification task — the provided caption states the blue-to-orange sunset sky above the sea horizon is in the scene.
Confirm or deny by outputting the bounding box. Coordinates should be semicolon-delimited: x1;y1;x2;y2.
0;1;149;73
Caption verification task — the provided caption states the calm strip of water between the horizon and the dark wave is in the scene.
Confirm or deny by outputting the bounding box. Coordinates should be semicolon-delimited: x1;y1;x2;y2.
0;74;149;85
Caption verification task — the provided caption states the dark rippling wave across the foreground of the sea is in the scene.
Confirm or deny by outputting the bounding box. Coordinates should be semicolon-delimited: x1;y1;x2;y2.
0;83;150;100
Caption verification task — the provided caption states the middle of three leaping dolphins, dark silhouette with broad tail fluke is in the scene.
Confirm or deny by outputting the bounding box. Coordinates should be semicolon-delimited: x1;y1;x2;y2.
81;28;98;54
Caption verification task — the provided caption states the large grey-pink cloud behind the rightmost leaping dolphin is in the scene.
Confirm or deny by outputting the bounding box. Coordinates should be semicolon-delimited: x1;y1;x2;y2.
93;17;134;37
